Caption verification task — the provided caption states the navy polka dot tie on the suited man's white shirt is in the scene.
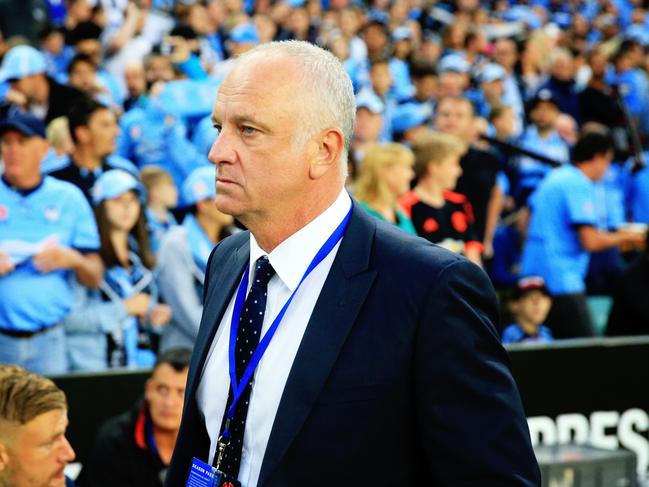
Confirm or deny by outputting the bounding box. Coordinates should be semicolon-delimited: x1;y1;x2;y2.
220;255;275;478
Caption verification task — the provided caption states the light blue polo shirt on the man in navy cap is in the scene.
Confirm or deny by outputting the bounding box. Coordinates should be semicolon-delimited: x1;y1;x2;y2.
0;176;99;331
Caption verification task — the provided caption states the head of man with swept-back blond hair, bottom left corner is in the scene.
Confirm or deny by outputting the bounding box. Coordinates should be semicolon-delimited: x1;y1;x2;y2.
0;365;74;487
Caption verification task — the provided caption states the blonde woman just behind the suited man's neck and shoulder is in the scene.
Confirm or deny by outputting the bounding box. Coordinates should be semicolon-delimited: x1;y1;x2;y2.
354;144;416;235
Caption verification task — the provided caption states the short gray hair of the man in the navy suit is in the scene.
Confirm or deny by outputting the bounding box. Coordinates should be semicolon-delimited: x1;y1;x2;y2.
237;41;356;174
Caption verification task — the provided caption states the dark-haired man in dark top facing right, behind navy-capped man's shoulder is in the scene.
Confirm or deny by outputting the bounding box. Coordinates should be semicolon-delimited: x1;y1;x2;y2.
50;98;138;201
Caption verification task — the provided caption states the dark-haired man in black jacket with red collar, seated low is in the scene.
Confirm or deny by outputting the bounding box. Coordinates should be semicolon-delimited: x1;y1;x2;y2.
77;348;191;487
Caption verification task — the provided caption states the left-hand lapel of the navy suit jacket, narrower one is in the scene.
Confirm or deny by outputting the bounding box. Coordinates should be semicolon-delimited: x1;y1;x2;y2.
188;234;250;397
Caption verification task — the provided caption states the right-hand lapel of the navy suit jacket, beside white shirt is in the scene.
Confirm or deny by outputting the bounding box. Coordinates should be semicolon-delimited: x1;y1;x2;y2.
258;204;376;486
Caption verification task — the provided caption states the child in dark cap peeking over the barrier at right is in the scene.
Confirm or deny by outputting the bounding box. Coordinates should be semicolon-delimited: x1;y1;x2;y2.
503;276;554;343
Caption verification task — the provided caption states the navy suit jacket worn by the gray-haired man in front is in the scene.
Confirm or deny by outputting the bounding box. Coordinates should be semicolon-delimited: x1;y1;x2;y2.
165;200;540;487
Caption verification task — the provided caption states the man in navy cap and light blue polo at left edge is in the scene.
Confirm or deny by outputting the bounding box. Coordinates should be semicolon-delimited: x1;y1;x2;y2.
0;114;103;374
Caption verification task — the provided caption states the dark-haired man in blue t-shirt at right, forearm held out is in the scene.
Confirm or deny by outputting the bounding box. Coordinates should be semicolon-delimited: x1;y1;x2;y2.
521;127;642;338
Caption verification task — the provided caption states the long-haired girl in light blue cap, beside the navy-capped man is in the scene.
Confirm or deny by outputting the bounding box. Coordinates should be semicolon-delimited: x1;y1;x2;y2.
64;169;171;370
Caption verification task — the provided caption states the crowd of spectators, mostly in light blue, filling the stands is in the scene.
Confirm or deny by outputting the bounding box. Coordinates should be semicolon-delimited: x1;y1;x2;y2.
0;0;649;380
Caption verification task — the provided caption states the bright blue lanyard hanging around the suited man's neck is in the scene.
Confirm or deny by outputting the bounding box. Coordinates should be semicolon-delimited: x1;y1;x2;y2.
223;204;352;440
